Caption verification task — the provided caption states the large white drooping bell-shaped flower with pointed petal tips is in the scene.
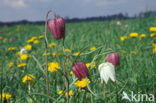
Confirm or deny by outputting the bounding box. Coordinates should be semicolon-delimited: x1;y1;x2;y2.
98;62;115;84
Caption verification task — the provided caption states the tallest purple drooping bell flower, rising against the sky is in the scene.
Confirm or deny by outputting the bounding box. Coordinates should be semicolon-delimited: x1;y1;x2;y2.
48;17;65;40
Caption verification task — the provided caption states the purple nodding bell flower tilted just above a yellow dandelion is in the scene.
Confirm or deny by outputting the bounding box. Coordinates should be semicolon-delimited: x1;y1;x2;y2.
72;62;89;80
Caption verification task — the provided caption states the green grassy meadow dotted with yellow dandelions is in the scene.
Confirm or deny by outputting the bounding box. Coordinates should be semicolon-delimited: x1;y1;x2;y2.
0;17;156;103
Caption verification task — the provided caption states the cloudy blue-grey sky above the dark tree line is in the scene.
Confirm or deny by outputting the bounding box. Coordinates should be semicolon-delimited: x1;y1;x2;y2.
0;0;156;21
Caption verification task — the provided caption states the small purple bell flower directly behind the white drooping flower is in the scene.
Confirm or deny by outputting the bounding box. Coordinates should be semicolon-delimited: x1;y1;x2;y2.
107;53;120;66
